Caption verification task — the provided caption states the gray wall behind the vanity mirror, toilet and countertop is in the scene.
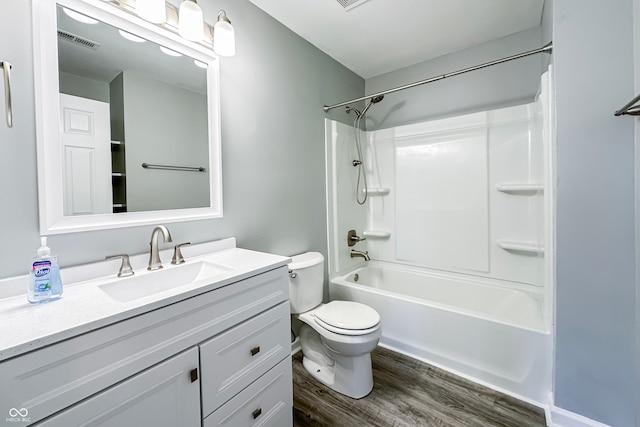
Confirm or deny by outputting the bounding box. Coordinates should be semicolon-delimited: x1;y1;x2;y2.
0;0;364;278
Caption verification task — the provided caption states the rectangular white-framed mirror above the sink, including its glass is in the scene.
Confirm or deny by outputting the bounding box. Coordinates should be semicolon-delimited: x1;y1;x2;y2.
33;0;222;234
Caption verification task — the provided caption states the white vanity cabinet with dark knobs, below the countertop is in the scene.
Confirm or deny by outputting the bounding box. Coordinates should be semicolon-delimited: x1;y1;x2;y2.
0;266;292;427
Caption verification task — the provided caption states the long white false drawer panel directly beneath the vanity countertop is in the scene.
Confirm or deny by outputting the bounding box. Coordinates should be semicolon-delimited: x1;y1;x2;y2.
0;267;289;422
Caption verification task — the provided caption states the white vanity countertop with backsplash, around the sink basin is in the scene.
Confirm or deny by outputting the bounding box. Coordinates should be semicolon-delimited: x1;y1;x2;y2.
0;238;290;361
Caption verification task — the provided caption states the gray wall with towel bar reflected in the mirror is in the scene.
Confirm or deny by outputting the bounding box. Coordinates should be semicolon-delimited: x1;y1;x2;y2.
122;70;210;212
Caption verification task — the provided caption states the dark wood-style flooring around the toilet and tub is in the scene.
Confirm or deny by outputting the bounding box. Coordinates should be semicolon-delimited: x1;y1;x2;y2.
293;347;546;427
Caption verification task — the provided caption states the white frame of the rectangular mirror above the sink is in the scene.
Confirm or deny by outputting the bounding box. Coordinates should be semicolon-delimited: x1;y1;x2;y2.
32;0;222;235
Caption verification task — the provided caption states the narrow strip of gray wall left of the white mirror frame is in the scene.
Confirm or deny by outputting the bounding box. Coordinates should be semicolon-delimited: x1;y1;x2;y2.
0;0;39;278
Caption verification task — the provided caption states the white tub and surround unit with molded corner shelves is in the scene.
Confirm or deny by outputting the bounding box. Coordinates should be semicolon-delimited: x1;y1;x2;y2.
326;72;555;406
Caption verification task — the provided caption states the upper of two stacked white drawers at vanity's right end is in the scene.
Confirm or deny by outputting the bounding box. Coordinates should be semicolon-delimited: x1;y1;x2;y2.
200;302;291;416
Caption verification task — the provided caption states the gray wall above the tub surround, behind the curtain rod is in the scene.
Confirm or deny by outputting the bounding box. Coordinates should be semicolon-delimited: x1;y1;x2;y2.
365;27;547;130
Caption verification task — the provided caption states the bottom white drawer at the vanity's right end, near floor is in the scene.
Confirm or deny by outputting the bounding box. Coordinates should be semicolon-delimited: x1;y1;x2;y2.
202;357;293;427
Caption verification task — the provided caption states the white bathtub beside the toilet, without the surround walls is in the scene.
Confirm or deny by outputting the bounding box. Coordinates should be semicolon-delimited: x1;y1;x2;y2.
329;261;551;406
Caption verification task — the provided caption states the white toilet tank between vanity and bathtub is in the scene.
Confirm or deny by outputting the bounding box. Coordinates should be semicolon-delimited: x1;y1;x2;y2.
289;252;324;314
